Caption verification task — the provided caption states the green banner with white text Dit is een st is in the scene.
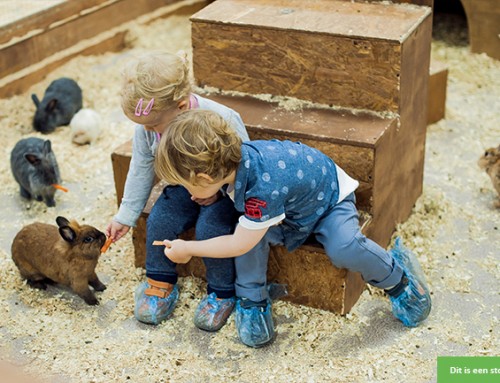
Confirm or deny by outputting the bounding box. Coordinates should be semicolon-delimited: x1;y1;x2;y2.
437;356;500;383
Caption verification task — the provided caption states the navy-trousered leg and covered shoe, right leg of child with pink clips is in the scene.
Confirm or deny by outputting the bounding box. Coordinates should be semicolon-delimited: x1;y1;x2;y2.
194;196;237;331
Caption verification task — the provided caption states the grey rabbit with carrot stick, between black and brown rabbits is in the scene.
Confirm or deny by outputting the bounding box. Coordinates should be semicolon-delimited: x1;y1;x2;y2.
10;137;61;207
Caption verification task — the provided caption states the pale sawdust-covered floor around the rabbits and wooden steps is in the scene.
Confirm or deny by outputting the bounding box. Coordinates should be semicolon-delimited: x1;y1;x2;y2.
0;9;500;383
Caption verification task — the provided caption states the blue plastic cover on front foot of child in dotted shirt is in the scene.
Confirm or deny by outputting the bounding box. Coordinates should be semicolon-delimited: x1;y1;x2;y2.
235;299;274;348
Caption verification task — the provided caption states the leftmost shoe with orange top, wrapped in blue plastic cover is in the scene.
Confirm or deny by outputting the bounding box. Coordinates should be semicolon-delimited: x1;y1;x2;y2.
134;278;179;324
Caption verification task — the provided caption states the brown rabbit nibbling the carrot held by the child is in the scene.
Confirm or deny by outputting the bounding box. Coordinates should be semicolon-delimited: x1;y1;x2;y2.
11;217;106;305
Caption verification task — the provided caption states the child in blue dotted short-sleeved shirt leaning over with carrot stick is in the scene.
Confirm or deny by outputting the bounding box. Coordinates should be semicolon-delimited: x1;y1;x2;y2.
155;110;431;347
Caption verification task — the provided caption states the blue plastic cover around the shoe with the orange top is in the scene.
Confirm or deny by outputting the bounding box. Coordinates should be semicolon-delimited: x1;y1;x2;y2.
134;282;179;324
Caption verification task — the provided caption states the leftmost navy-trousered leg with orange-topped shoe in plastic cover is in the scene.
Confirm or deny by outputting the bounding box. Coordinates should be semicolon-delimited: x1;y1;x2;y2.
134;186;199;324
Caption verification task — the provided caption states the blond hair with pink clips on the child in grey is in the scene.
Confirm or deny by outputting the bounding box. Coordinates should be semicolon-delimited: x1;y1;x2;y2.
121;52;193;113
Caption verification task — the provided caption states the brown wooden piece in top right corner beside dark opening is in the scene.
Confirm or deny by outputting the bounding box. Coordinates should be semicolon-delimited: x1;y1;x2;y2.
461;0;500;60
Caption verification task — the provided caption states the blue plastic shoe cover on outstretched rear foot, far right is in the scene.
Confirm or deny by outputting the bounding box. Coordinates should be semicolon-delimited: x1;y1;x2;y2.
390;237;432;327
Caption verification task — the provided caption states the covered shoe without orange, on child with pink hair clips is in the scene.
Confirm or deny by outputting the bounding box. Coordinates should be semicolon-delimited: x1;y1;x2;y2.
194;293;236;331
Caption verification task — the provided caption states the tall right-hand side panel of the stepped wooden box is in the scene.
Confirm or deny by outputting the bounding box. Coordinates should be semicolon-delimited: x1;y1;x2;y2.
370;17;432;246
